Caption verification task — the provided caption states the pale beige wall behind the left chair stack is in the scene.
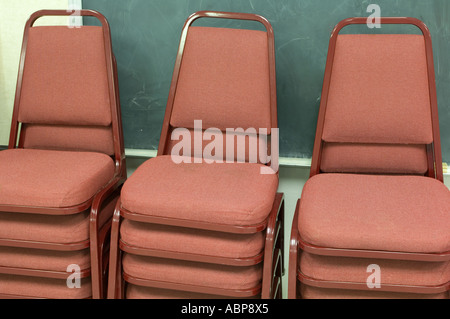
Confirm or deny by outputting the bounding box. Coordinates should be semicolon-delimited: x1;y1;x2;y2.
0;0;68;145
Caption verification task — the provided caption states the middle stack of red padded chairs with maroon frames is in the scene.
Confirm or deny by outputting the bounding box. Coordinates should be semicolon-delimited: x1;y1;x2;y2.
108;11;284;299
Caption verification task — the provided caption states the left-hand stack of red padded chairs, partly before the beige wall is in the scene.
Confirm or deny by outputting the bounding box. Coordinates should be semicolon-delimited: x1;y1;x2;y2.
0;10;126;299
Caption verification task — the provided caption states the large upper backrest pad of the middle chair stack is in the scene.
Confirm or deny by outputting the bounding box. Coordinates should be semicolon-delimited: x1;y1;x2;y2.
170;27;271;134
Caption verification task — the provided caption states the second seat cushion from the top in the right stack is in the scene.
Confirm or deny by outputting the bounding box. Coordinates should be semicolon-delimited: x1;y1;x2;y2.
299;252;450;287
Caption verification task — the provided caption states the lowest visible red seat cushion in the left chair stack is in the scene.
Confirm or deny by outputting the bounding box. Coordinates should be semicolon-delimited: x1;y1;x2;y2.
0;274;92;299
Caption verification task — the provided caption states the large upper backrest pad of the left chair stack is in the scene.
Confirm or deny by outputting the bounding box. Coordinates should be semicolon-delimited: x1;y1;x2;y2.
19;26;111;126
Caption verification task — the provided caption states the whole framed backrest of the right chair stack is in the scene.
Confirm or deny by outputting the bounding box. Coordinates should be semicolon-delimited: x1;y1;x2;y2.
311;18;442;182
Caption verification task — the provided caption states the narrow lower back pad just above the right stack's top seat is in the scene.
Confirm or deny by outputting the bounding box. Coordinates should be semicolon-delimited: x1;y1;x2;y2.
320;143;428;175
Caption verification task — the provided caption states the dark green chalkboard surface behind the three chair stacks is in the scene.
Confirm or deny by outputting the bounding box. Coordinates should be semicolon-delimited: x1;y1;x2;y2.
83;0;450;162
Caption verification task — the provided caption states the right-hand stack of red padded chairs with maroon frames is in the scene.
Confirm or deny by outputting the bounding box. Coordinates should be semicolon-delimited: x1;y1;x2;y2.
288;18;450;299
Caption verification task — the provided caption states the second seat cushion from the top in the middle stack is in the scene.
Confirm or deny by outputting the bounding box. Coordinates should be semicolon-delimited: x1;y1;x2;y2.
120;219;265;258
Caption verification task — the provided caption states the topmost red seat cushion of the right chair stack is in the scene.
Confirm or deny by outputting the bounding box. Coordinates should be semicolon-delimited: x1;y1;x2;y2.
298;174;450;253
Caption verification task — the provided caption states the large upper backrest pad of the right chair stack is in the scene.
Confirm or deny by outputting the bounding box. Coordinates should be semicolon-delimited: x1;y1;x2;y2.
323;34;433;144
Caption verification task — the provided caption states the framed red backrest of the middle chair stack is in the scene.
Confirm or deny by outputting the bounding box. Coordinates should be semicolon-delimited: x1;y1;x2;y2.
158;12;277;164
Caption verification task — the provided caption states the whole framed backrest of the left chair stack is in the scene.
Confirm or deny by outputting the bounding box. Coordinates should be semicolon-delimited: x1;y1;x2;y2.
10;10;123;166
